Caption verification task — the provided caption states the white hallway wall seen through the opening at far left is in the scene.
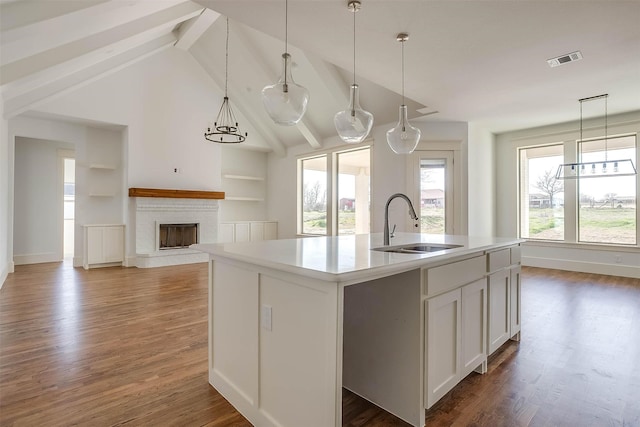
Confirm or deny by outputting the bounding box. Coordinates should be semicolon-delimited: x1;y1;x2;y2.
13;137;73;265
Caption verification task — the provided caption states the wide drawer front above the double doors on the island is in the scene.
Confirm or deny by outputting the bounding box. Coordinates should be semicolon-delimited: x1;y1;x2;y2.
426;255;486;296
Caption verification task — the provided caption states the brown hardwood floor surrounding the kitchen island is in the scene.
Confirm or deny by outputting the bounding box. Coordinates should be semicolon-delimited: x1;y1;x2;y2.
0;263;640;427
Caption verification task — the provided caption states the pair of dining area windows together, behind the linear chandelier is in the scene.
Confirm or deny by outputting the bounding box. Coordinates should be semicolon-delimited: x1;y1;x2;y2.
518;135;638;245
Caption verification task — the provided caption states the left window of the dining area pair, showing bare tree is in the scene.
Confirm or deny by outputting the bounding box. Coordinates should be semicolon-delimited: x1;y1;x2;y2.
519;144;564;240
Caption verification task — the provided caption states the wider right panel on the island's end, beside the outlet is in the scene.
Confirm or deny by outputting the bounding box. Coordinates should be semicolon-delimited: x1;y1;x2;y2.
259;274;342;427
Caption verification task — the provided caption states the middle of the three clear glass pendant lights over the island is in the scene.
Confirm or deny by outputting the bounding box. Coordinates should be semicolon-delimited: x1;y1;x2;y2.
333;0;373;144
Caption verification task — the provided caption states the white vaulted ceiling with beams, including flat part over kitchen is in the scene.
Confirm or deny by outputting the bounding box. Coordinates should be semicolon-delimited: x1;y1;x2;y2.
0;0;640;151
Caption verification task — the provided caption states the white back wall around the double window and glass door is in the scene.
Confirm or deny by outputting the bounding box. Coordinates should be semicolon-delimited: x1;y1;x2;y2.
267;122;468;239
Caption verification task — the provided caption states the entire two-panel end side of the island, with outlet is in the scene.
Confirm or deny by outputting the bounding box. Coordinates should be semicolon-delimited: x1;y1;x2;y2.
209;258;342;427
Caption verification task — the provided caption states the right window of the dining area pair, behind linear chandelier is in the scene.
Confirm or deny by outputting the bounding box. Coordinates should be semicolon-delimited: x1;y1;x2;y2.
578;136;637;245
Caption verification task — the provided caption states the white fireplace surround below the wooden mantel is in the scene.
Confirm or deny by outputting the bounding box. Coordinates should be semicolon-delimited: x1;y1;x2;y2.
133;197;219;268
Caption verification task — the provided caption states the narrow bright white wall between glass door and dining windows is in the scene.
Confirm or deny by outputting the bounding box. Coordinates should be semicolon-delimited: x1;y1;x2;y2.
468;123;496;236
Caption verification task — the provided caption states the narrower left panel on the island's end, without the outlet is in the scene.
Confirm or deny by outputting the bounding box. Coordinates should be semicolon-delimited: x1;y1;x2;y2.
209;260;259;416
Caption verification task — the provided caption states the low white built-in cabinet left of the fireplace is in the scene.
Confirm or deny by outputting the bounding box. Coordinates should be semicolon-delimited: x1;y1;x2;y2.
83;224;124;269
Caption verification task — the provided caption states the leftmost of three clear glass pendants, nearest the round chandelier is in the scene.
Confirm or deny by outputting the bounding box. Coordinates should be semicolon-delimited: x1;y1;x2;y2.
262;0;309;126
